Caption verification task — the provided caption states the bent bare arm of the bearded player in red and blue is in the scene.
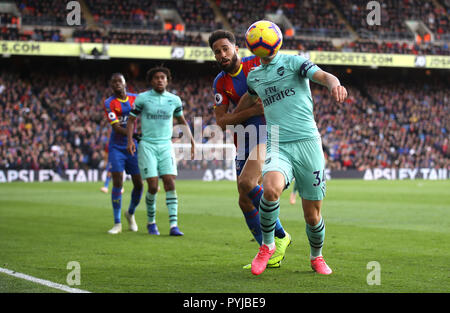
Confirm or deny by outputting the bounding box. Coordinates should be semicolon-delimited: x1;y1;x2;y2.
215;93;264;130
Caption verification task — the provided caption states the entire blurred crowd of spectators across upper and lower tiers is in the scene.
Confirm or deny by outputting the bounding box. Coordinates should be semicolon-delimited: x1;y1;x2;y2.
0;0;450;172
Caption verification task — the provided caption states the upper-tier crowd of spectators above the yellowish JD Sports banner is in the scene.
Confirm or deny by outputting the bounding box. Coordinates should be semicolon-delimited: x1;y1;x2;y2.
0;0;450;55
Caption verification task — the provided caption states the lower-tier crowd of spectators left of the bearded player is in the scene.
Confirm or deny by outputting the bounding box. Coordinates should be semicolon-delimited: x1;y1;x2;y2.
0;66;221;172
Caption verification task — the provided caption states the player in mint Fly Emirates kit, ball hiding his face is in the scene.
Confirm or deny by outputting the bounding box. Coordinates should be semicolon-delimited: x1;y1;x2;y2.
239;21;347;275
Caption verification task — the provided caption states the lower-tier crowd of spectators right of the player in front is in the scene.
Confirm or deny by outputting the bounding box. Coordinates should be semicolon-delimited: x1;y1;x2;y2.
313;78;450;170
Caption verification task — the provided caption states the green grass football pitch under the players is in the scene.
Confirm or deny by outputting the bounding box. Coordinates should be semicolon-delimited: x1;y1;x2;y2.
0;180;450;293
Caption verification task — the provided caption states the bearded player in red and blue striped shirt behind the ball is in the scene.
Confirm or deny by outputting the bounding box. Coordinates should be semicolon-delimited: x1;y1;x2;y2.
209;30;291;268
